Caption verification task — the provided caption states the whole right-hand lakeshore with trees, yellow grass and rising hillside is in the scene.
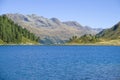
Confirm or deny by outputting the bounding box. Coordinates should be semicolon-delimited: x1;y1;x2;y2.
68;22;120;45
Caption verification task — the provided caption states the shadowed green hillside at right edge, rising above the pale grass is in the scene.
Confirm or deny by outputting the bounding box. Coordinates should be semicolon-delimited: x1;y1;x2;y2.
97;22;120;39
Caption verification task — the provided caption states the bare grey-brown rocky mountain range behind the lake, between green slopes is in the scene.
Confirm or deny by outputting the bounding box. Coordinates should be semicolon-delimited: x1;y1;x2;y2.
6;14;101;44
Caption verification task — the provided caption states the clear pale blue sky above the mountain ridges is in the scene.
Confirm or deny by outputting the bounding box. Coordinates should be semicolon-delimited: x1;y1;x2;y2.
0;0;120;28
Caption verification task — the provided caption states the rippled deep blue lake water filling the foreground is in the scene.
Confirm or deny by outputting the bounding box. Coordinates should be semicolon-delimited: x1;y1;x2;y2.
0;46;120;80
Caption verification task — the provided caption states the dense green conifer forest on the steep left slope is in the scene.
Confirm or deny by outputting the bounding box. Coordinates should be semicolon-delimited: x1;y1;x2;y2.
0;15;39;44
